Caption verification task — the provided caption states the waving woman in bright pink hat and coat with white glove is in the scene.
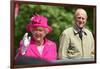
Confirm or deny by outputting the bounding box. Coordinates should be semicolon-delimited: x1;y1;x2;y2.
17;14;57;61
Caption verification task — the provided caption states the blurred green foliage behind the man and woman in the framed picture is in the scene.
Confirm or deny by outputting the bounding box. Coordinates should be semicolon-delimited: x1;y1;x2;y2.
14;4;93;49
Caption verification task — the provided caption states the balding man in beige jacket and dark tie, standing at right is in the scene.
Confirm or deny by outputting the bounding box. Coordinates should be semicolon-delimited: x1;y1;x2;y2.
58;8;94;59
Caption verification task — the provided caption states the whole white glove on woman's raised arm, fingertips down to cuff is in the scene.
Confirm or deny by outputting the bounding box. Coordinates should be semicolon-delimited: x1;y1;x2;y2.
21;33;31;55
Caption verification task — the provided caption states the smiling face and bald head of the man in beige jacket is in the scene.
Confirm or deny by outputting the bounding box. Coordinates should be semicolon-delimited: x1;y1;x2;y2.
75;10;87;28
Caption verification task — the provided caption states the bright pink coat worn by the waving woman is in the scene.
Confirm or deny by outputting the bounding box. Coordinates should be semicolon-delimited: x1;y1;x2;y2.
16;39;57;61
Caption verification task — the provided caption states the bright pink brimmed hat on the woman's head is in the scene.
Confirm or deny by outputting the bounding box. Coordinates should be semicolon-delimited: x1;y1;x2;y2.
26;14;52;32
